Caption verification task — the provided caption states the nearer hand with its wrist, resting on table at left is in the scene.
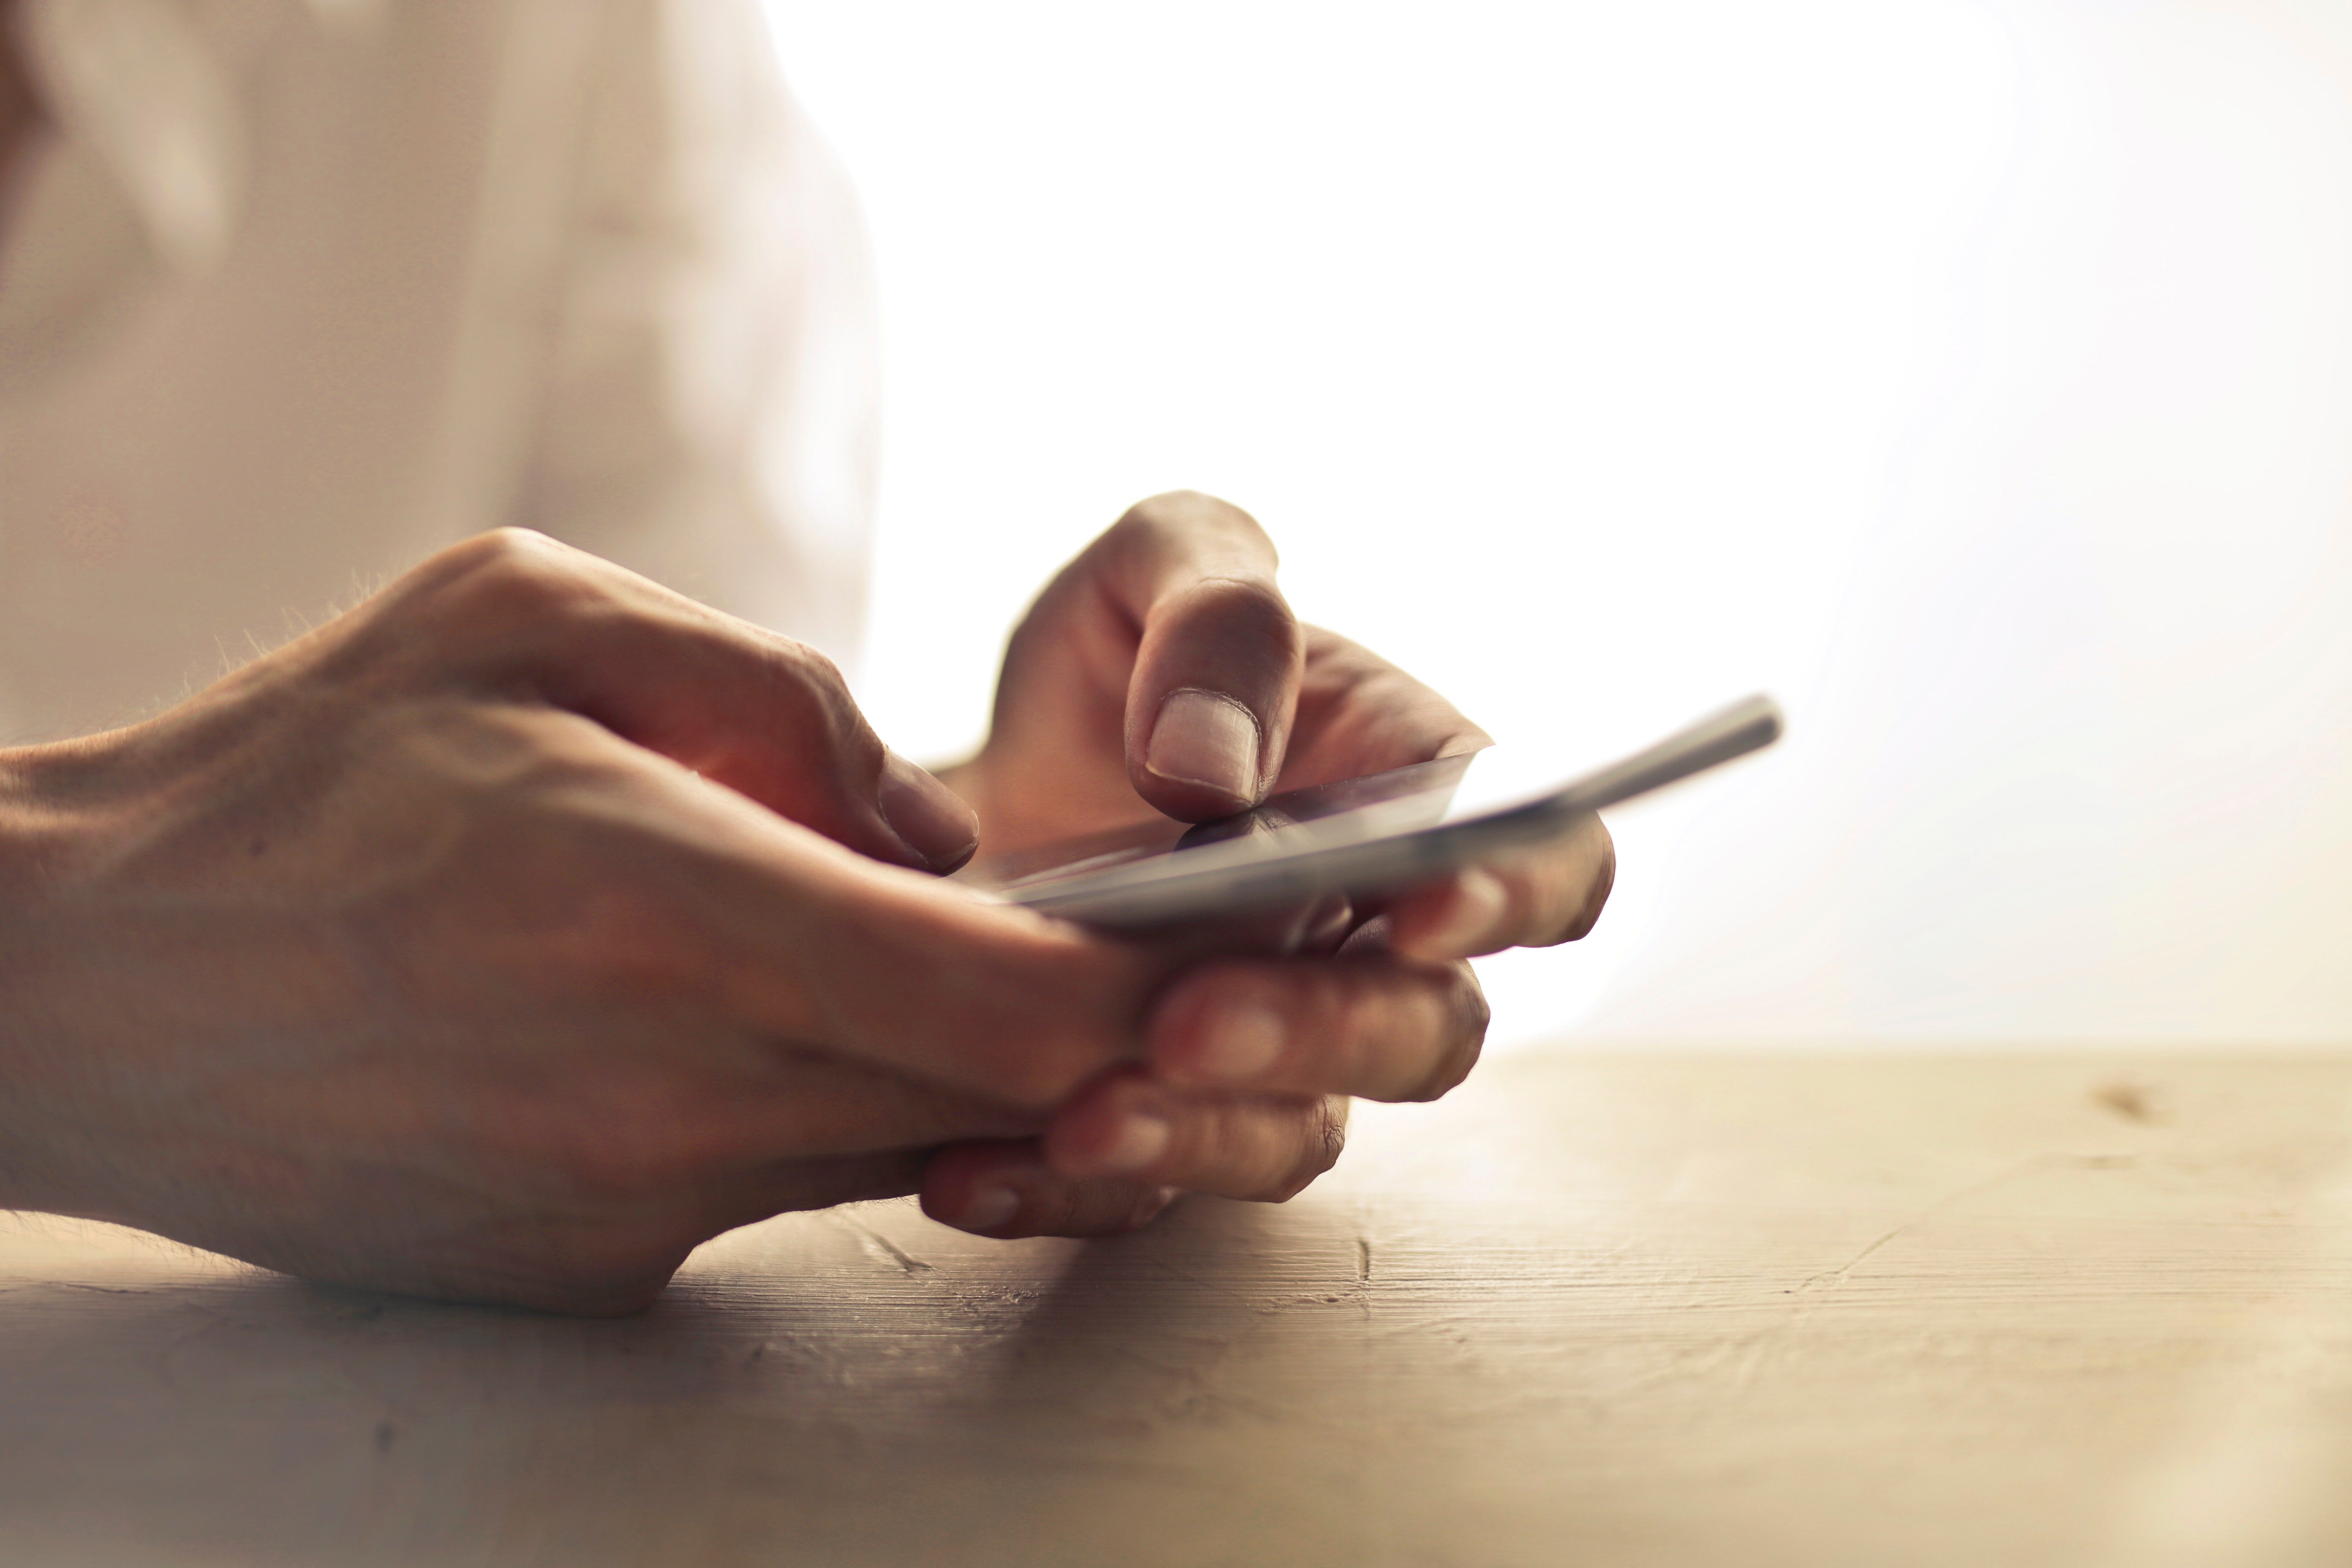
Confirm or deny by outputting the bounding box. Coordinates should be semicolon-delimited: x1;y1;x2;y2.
0;533;1251;1312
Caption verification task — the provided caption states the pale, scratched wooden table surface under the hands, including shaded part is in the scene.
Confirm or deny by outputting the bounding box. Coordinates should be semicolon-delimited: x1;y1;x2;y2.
0;1053;2352;1568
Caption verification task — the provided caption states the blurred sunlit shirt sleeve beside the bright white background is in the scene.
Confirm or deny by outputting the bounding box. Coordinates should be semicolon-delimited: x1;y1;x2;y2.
513;0;877;663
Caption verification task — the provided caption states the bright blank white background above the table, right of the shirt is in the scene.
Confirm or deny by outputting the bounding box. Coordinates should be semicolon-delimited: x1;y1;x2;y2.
771;0;2352;1044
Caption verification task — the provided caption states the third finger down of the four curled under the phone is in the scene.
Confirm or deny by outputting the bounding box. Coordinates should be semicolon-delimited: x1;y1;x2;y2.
1044;1070;1348;1203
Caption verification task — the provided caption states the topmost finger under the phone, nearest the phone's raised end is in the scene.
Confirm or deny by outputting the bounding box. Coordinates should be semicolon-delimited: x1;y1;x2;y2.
1385;816;1616;962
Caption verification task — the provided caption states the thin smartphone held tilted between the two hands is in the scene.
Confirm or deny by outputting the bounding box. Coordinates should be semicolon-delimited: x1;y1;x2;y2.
957;696;1780;931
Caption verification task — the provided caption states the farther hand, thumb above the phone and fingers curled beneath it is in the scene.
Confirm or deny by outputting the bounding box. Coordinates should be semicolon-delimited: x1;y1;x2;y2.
924;491;1616;1236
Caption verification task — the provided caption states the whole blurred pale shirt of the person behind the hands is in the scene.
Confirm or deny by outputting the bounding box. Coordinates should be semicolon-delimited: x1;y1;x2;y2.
0;0;875;743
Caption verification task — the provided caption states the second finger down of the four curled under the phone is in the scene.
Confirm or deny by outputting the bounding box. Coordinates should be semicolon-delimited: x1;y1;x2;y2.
1148;945;1486;1100
